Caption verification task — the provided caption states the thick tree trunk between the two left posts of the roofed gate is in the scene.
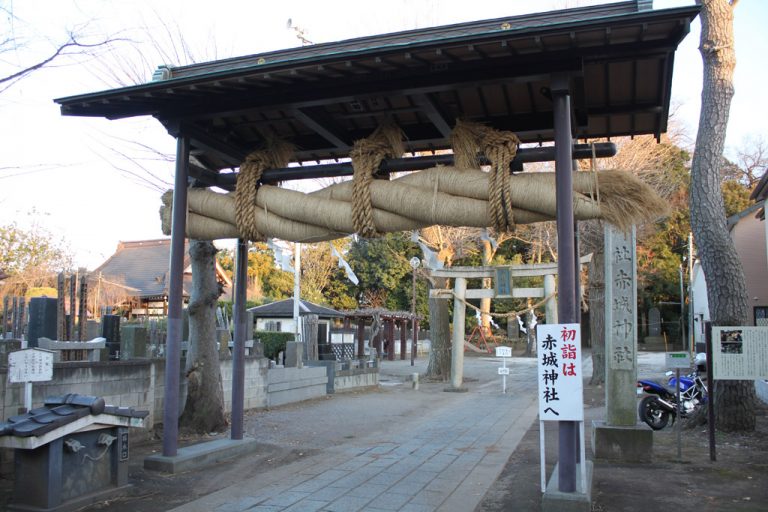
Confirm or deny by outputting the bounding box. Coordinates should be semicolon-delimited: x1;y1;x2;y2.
179;240;227;434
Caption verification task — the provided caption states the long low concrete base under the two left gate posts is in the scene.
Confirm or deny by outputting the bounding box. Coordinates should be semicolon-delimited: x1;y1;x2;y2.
144;439;258;473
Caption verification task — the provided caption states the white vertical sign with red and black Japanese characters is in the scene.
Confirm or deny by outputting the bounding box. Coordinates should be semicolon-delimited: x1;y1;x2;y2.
536;324;584;421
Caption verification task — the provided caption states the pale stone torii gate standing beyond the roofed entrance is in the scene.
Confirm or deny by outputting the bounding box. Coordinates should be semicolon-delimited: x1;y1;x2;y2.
429;254;592;391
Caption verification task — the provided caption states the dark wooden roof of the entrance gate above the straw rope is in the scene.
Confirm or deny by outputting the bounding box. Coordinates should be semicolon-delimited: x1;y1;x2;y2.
55;0;699;185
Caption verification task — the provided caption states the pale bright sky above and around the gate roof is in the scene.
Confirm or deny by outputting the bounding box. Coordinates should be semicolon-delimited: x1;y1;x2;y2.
0;0;768;269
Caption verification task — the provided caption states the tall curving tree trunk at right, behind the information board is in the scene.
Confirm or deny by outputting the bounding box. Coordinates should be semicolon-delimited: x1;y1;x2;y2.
690;0;755;431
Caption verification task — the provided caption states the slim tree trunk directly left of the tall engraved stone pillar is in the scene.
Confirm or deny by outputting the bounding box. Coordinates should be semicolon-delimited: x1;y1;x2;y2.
589;250;605;386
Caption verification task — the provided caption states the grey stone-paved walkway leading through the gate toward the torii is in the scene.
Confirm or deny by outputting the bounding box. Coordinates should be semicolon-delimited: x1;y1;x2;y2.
168;358;538;512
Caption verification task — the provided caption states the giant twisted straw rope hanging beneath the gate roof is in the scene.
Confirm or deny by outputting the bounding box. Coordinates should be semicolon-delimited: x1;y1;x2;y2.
161;123;667;242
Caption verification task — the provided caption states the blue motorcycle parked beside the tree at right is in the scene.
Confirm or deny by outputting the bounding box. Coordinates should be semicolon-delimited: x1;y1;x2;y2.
637;370;707;430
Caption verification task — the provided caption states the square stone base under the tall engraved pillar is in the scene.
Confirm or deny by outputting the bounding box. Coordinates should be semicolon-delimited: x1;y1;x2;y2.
592;421;653;462
